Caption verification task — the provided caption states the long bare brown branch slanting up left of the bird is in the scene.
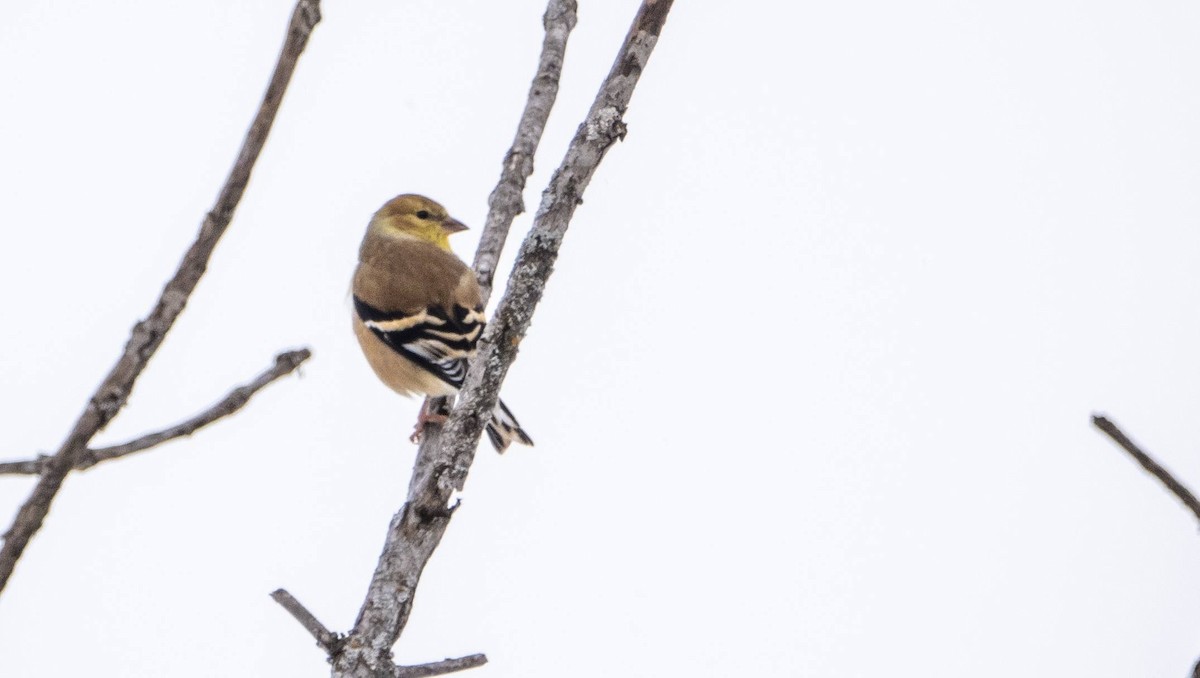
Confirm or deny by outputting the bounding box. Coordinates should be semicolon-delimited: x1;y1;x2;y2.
0;0;320;590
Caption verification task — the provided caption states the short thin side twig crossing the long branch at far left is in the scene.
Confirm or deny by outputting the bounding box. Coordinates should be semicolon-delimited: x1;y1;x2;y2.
0;348;312;475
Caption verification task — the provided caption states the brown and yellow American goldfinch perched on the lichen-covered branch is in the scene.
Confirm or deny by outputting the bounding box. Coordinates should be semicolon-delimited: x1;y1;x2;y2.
353;194;533;452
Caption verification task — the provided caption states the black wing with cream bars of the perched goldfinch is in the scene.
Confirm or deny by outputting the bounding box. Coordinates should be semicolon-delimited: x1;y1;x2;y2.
354;295;485;389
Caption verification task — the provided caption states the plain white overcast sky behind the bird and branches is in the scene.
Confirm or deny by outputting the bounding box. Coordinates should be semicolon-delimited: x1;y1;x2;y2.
0;0;1200;678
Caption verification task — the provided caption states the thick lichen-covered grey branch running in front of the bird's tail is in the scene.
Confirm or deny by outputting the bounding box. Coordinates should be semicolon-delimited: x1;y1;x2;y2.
332;0;673;678
